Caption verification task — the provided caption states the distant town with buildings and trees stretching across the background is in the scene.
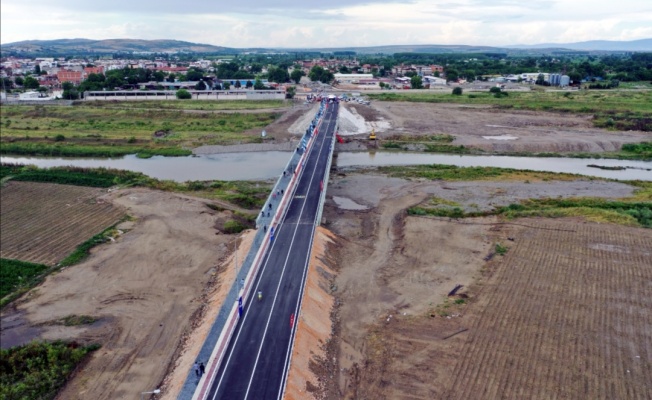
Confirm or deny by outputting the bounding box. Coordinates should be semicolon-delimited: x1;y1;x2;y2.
0;53;652;101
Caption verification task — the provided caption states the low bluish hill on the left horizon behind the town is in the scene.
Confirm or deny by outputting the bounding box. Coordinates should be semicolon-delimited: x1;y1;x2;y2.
2;39;232;55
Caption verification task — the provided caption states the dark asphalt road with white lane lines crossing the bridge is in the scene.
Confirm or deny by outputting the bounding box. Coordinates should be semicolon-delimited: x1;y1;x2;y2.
207;103;339;400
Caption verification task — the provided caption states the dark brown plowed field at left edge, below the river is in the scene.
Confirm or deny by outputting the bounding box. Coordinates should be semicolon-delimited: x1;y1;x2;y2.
0;182;124;265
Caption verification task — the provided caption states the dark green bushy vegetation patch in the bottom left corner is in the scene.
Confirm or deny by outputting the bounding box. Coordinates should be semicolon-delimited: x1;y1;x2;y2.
0;341;99;400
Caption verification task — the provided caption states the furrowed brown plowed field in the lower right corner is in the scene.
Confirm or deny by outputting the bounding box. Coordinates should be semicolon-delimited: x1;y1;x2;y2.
445;220;652;399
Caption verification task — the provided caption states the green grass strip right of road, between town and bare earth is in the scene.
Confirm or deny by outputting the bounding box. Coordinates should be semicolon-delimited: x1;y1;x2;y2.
368;90;652;132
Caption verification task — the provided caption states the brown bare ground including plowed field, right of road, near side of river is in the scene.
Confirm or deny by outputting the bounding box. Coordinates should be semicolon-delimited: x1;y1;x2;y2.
325;174;652;399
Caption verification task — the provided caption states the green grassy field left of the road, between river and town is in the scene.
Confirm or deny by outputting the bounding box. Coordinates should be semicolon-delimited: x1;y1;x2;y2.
0;101;283;157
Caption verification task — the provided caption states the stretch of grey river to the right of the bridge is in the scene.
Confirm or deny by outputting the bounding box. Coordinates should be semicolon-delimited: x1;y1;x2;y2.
337;152;652;181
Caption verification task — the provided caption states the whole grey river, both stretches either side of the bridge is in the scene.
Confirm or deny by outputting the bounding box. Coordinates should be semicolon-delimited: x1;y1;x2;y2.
0;151;652;182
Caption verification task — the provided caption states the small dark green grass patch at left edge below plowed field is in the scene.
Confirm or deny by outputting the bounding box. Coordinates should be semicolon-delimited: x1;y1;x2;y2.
0;258;49;305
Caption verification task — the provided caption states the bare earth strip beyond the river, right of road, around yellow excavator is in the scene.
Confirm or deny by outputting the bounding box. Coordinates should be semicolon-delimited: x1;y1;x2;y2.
340;101;650;153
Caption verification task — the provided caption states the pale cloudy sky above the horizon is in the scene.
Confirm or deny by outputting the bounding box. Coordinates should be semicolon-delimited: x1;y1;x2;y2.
0;0;652;47
